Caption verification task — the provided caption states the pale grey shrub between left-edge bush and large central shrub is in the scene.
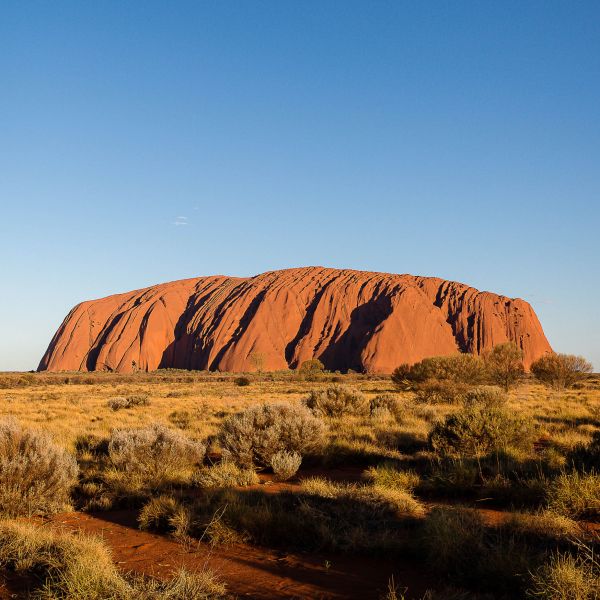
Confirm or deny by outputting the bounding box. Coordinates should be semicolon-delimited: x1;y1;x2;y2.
108;424;206;488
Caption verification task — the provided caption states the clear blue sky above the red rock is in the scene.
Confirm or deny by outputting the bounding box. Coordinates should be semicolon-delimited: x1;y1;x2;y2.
0;0;600;370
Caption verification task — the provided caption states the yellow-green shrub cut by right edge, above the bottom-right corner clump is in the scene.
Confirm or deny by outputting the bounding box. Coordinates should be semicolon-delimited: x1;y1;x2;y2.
548;471;600;519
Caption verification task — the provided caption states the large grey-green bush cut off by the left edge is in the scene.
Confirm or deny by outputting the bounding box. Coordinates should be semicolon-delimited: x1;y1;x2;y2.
0;419;79;516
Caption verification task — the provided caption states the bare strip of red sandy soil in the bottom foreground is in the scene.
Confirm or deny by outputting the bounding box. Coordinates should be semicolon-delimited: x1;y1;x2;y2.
14;511;426;600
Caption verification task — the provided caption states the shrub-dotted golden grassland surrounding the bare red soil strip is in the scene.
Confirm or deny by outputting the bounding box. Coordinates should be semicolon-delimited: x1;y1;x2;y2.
0;366;600;600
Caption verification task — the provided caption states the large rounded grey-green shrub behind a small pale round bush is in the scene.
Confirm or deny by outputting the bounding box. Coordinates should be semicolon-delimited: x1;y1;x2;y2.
218;403;325;467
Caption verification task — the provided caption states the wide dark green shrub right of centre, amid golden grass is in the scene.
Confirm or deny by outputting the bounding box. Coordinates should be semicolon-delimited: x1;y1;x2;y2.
429;404;534;457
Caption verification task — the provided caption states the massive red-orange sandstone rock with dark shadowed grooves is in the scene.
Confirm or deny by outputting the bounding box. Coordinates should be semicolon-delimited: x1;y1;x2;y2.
39;267;551;373
